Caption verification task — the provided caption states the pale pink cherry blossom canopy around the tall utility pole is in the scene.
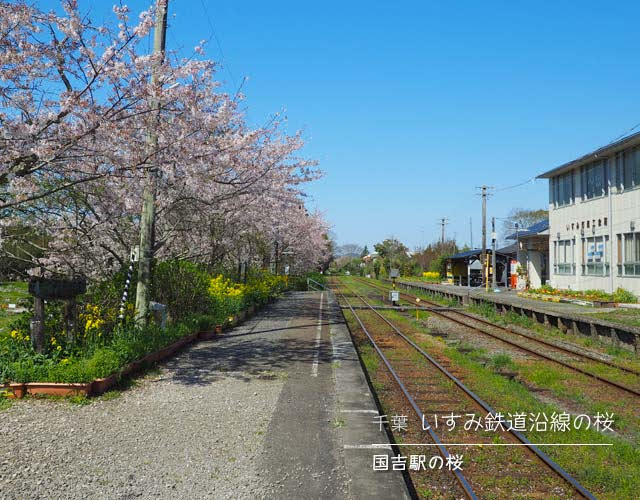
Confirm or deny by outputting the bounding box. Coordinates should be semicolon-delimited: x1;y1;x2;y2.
0;0;327;284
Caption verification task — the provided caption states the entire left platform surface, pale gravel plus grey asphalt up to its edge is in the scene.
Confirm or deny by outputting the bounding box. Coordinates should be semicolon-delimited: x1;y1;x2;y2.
0;292;408;499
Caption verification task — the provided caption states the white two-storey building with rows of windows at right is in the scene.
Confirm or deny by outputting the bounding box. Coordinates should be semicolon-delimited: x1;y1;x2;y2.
538;133;640;295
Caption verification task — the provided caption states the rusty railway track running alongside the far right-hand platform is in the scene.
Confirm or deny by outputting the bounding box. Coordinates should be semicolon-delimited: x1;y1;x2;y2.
355;278;640;396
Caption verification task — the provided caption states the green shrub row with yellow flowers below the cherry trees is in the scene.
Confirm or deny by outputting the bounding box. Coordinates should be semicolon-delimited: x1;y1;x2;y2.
0;261;287;383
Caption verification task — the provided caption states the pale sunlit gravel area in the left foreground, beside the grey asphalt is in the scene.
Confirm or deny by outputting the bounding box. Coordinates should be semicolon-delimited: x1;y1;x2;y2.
0;364;283;499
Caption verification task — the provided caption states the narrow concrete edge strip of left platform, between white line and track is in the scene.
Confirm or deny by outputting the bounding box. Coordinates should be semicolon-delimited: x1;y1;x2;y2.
327;292;411;499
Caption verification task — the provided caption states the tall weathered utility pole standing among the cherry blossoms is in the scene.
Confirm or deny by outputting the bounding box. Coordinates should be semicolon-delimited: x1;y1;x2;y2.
136;0;169;324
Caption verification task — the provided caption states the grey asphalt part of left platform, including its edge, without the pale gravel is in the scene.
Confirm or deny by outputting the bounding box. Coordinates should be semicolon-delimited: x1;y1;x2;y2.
218;291;410;499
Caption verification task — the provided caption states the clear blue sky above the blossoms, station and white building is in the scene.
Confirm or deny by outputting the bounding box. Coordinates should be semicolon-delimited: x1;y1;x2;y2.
41;0;640;248
